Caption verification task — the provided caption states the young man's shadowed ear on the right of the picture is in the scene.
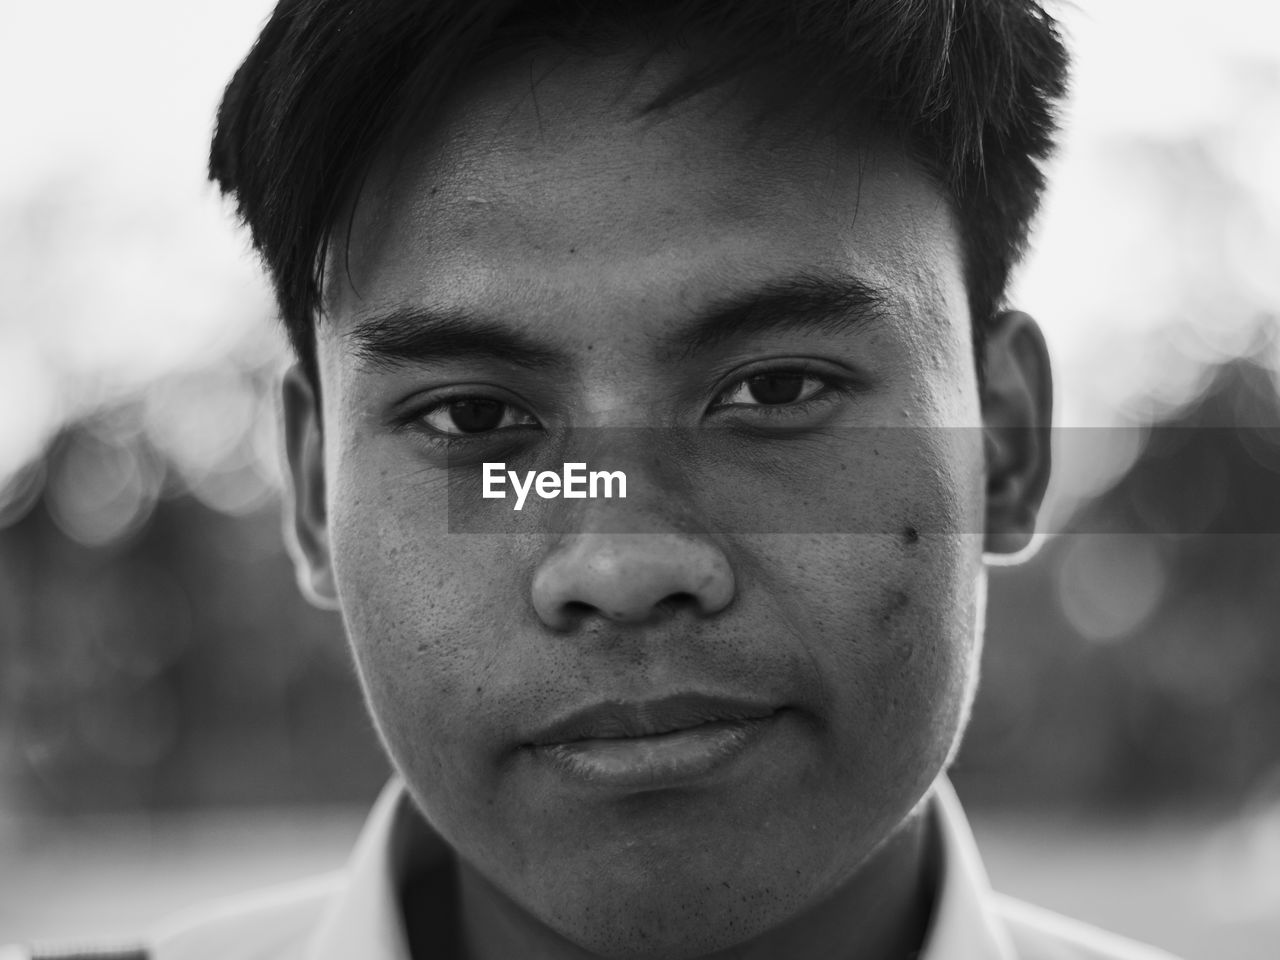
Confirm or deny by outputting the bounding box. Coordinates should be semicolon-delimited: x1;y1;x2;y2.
982;311;1053;554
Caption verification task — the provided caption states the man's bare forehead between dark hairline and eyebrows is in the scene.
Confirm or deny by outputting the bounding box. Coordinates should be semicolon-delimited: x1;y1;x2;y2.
326;48;951;340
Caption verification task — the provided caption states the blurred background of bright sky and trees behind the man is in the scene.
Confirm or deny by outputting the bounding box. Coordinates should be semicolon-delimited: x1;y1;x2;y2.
0;0;1280;960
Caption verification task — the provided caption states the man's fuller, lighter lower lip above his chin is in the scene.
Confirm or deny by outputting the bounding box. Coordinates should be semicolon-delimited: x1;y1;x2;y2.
535;713;778;790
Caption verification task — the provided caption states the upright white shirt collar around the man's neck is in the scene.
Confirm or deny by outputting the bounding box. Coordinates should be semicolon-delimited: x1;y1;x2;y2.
306;777;1014;960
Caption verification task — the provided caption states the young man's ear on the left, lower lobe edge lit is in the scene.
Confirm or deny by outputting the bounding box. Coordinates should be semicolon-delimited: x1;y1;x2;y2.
282;364;338;609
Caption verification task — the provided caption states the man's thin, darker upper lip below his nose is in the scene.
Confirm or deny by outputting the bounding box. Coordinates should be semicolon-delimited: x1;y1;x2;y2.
530;694;778;746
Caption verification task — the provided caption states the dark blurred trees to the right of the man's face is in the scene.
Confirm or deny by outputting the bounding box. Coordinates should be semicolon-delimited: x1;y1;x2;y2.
956;345;1280;805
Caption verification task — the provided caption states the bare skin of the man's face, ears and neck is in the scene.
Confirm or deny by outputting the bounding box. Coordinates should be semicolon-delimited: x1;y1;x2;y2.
285;48;1048;957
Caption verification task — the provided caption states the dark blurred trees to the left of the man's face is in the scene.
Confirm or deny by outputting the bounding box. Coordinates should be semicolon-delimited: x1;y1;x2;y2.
0;384;387;812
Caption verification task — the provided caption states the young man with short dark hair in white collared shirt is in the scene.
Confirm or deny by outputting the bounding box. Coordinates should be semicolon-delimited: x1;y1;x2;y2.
10;0;1182;960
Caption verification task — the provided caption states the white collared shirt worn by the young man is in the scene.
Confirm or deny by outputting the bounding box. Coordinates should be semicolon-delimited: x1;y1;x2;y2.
10;777;1172;960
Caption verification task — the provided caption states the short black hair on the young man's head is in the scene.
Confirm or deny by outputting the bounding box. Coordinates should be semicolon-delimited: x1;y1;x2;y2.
209;0;1068;385
